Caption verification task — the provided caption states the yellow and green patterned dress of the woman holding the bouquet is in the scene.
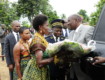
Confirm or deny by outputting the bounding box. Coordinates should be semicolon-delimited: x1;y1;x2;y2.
22;33;49;80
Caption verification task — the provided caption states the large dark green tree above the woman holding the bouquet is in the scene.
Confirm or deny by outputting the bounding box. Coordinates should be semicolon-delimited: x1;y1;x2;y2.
17;0;58;22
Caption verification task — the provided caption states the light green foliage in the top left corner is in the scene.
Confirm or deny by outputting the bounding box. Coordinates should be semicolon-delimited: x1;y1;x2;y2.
0;1;19;26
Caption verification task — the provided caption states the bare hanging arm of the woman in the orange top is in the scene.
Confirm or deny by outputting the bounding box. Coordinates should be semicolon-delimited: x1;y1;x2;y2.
13;43;22;79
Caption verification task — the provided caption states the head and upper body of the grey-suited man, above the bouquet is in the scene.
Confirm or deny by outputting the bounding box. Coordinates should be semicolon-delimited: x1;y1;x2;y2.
68;15;94;44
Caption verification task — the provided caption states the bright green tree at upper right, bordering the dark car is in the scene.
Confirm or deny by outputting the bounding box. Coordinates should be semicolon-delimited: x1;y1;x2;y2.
90;0;105;26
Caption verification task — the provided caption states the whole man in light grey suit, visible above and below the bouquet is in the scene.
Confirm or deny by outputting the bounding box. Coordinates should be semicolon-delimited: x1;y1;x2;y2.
68;14;94;80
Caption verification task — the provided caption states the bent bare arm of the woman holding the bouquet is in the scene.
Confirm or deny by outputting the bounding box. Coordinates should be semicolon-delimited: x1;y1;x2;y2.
35;50;53;67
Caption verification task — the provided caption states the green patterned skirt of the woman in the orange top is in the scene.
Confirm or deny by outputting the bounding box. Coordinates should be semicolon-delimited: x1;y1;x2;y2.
13;59;30;80
